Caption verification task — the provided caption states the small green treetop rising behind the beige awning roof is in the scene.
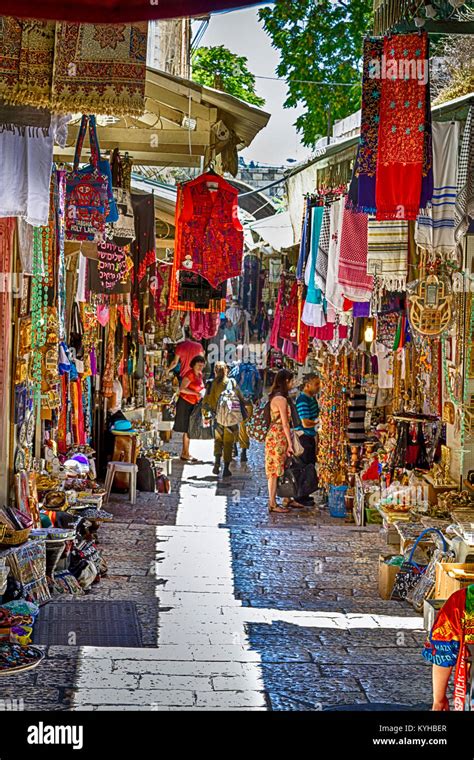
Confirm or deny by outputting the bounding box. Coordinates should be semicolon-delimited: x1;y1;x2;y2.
192;45;265;106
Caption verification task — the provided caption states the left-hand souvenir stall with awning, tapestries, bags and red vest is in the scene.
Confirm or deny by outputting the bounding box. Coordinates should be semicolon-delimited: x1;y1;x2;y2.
0;17;269;672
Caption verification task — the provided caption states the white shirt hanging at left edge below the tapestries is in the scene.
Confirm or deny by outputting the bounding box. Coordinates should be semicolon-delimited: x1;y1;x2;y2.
0;115;71;227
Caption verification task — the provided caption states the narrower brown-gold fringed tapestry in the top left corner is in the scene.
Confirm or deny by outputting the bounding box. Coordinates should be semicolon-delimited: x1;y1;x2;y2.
0;16;56;107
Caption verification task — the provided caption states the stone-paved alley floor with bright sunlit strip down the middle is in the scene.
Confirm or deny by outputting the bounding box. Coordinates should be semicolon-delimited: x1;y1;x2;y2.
2;441;431;711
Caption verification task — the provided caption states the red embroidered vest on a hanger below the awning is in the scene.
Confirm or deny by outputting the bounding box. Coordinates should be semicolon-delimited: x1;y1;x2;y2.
175;173;244;287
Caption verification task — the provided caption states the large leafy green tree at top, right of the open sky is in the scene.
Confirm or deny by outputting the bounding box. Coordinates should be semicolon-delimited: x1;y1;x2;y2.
260;0;373;146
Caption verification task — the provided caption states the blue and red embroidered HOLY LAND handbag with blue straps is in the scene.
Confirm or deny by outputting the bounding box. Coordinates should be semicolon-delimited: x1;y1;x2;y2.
65;115;112;242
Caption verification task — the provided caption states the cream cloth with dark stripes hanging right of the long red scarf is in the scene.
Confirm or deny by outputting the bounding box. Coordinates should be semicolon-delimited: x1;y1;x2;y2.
415;121;459;256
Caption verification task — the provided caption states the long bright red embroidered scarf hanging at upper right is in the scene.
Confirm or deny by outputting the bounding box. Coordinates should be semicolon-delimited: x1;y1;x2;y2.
375;32;429;220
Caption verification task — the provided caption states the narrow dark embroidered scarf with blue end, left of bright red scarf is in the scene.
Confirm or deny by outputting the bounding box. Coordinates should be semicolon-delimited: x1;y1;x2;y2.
354;37;383;214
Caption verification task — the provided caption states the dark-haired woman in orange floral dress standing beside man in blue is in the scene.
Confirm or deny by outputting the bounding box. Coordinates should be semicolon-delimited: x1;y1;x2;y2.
265;369;294;512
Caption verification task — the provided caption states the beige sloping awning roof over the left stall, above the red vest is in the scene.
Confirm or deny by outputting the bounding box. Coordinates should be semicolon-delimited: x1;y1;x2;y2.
54;69;270;172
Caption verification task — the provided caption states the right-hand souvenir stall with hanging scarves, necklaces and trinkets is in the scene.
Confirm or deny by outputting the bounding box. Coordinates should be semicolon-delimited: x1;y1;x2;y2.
286;28;474;608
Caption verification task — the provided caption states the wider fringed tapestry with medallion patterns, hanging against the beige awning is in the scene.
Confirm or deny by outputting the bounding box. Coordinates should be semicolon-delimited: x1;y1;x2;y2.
51;23;148;116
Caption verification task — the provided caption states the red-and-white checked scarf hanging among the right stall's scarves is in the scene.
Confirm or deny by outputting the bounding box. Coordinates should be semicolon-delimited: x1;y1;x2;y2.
338;208;374;301
